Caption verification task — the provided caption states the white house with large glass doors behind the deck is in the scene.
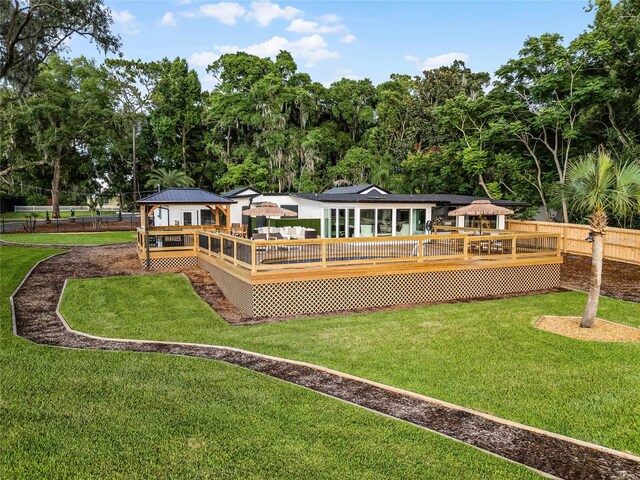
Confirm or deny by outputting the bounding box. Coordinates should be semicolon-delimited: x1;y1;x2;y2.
222;184;527;238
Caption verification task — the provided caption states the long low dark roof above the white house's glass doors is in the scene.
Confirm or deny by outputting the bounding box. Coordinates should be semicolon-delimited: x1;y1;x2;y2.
291;193;529;207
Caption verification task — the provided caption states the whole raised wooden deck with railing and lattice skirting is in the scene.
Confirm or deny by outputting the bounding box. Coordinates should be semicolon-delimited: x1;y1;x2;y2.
139;232;562;317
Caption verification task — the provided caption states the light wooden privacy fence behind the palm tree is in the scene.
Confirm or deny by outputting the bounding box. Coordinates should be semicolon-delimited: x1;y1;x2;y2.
507;220;640;265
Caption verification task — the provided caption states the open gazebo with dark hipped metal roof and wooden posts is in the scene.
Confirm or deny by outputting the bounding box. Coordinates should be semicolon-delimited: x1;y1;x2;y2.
137;187;236;234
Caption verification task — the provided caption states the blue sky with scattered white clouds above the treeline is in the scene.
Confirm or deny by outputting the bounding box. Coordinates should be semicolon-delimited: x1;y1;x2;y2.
70;0;593;89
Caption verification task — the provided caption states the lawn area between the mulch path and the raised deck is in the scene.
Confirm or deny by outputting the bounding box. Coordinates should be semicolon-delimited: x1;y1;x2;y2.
62;274;640;454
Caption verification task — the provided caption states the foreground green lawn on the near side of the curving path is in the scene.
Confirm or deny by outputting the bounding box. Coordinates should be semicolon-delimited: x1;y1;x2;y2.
0;246;538;479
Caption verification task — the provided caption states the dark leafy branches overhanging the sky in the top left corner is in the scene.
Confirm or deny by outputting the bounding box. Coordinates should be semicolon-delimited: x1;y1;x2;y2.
0;0;120;92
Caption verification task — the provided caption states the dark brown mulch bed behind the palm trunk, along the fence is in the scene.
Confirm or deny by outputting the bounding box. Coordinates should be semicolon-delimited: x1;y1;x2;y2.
560;255;640;302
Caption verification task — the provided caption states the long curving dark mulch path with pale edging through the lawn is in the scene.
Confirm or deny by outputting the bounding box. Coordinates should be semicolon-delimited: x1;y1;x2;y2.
10;246;640;479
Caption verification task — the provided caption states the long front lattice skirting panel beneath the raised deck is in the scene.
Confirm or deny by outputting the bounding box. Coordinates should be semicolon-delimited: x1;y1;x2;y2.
250;264;560;317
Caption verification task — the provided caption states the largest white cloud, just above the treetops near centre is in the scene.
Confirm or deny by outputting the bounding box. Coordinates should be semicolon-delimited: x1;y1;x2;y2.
215;34;340;67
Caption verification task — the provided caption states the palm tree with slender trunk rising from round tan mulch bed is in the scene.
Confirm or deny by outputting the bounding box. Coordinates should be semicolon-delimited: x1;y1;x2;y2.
561;150;640;328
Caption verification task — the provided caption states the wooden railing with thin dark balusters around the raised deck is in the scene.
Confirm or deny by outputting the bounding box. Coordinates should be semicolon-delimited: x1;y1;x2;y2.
138;229;560;272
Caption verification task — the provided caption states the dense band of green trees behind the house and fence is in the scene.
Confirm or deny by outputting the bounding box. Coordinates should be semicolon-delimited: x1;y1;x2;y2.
0;0;640;225
